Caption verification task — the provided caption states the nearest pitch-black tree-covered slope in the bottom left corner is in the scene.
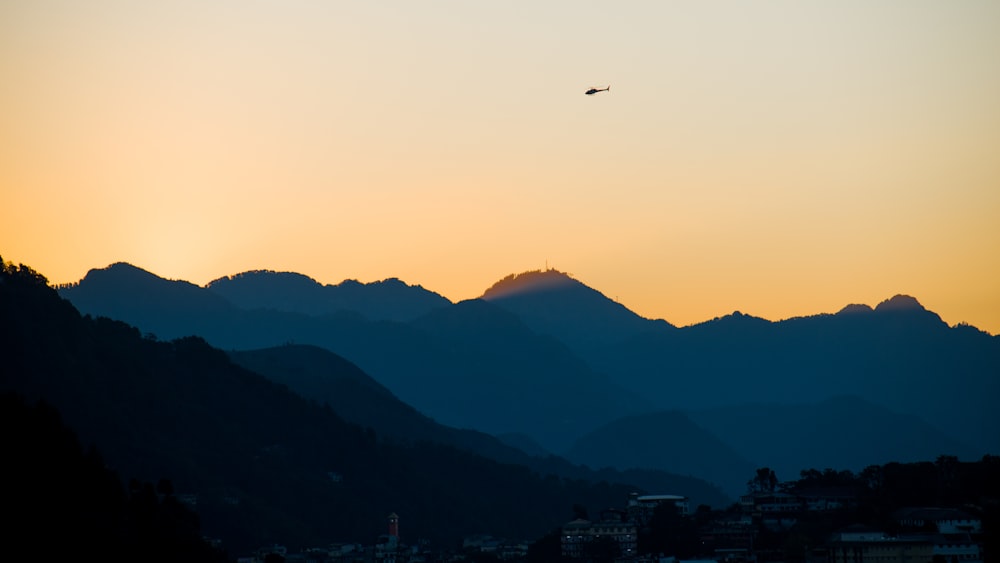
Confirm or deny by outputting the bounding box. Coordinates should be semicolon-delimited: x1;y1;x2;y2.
0;392;227;563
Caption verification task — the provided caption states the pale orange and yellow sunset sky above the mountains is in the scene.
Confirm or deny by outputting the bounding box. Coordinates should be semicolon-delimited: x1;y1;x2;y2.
0;0;1000;334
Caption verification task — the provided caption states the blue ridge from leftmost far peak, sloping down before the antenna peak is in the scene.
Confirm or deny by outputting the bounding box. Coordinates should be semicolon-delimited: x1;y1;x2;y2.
60;265;649;450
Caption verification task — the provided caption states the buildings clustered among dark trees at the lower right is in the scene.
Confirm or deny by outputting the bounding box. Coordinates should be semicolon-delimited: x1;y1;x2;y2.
561;487;984;563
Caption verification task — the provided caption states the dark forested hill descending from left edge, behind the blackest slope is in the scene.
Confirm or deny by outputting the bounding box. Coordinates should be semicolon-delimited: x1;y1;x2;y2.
0;258;664;553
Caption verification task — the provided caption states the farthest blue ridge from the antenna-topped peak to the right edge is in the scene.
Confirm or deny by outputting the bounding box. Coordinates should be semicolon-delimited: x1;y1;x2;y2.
483;270;1000;455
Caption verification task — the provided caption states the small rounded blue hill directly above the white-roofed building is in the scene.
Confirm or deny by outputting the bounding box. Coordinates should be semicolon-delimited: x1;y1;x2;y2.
566;411;760;498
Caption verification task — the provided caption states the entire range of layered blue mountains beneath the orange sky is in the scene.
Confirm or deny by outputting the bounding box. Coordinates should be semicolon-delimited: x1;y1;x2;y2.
59;264;1000;495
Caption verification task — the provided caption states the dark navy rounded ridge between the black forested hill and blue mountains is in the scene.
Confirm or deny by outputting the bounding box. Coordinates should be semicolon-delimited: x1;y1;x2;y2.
230;345;734;507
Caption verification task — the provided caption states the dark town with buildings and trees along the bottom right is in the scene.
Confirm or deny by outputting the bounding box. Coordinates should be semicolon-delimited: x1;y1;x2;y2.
239;456;1000;563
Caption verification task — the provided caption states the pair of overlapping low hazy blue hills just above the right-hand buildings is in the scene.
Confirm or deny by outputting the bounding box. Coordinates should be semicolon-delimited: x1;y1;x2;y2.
566;396;982;498
